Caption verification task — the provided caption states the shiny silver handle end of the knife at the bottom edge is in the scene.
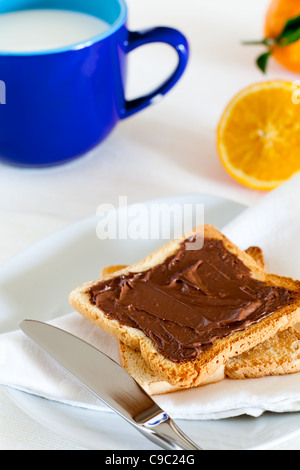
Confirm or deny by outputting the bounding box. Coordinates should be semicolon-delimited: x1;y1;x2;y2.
138;417;202;450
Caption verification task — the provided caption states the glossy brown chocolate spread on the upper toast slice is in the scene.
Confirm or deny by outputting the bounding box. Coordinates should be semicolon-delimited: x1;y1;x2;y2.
90;239;297;362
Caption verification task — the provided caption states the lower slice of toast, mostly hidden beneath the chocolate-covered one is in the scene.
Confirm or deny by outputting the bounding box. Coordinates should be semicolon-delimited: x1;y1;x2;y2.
102;247;300;395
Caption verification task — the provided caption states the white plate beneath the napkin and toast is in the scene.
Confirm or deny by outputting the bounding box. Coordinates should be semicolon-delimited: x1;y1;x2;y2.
0;194;300;450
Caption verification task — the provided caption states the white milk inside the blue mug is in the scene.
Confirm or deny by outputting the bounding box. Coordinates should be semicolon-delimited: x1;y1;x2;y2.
0;9;110;52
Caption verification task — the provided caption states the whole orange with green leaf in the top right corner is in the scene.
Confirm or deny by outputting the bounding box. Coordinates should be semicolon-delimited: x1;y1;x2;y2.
265;0;300;73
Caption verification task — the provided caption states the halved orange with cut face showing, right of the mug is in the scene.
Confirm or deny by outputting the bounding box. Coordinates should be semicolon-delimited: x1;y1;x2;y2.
217;80;300;190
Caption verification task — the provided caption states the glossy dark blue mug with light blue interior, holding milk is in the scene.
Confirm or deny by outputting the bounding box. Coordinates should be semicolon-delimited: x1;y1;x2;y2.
0;0;189;167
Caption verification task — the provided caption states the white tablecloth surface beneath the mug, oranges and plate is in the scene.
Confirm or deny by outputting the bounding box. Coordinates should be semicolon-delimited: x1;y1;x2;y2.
0;0;300;450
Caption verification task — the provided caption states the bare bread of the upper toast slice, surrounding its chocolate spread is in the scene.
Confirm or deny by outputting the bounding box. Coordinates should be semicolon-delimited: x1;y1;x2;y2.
70;225;300;388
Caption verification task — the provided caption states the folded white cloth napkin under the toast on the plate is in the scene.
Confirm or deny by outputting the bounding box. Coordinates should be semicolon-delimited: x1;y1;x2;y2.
0;175;300;419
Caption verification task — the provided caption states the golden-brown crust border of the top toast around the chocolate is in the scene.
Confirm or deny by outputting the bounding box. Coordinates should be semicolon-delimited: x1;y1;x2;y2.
70;225;300;388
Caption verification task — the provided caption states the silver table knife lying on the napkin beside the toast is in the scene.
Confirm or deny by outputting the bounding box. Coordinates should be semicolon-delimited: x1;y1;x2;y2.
20;320;201;450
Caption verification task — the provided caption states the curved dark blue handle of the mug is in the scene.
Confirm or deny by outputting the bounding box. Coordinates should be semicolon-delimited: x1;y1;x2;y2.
120;26;189;119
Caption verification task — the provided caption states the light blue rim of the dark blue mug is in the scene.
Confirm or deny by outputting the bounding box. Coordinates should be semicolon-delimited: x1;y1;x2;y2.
0;0;127;57
